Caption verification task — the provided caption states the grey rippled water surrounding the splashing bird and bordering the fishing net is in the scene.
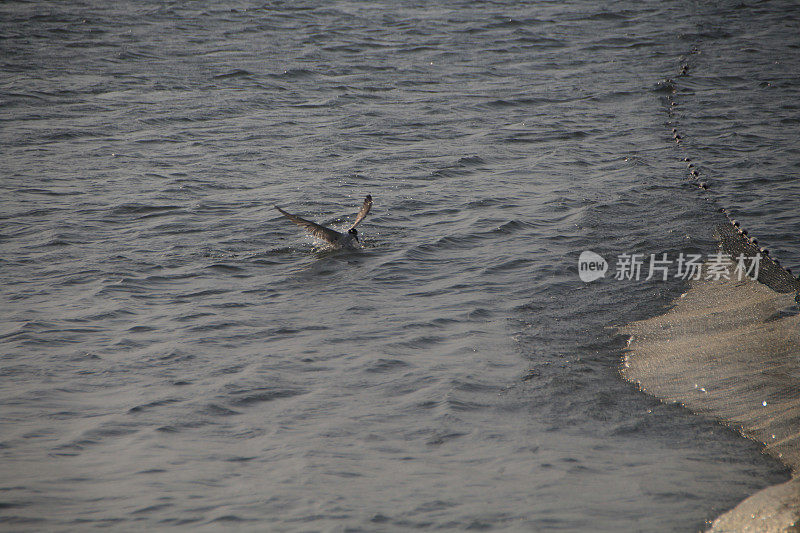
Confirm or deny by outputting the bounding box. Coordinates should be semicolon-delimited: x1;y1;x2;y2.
0;0;800;531
